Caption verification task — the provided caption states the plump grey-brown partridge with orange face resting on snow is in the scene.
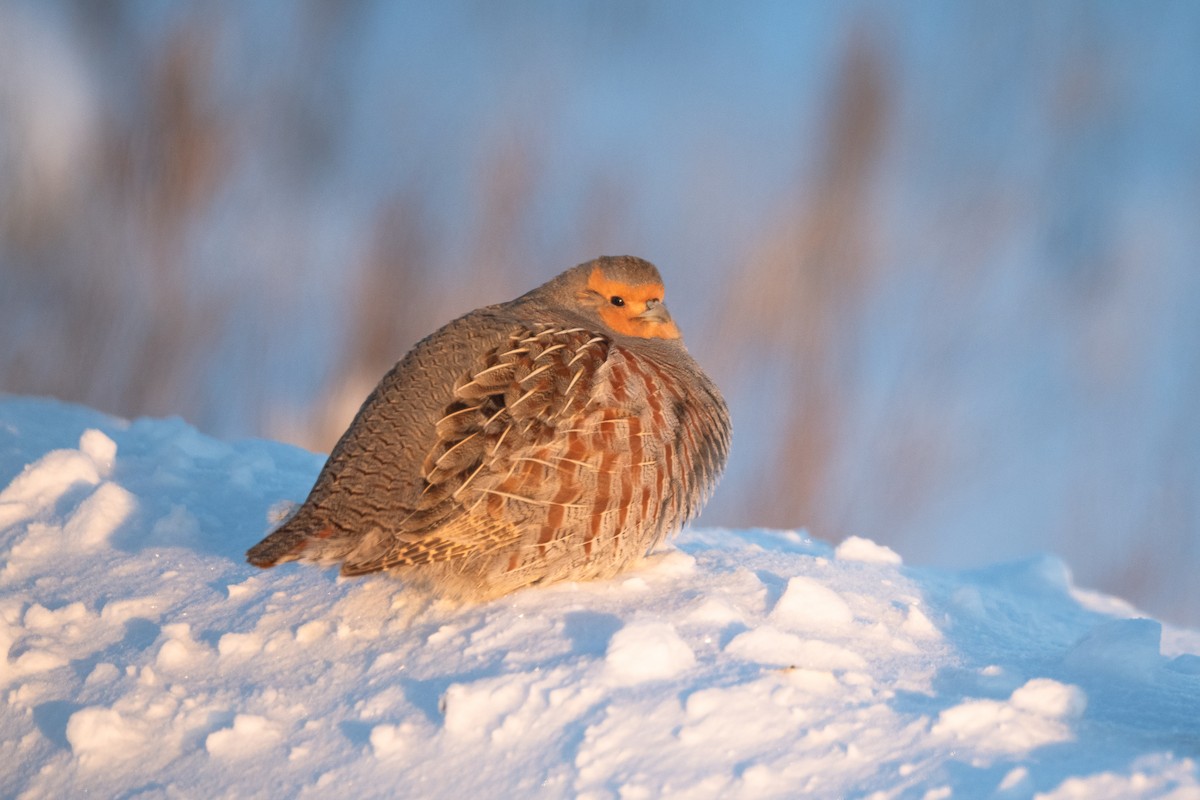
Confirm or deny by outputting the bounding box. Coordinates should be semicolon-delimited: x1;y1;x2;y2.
246;255;732;601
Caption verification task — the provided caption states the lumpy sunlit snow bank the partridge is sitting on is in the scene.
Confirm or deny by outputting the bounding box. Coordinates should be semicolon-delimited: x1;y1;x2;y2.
0;397;1200;798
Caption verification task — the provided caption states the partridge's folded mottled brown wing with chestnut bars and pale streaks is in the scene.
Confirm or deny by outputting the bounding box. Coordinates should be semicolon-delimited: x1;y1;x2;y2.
343;327;696;582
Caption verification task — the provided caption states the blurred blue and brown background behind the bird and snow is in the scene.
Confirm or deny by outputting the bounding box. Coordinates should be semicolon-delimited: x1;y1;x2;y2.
0;0;1200;626
